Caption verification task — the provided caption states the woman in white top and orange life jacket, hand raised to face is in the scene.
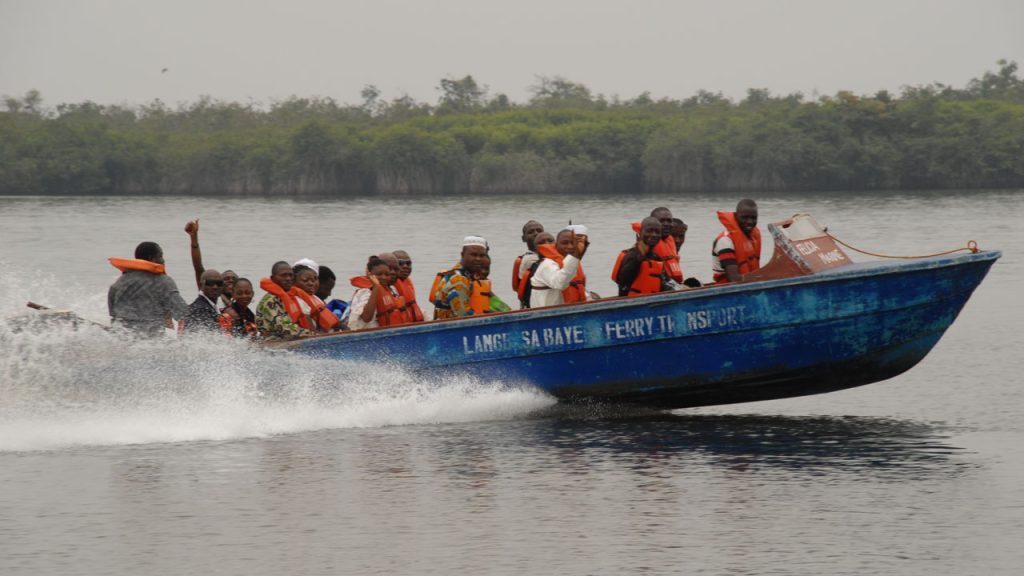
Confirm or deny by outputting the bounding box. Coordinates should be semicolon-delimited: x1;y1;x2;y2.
348;256;406;330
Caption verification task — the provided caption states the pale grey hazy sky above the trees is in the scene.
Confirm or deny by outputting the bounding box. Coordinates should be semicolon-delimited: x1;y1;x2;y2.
0;0;1024;106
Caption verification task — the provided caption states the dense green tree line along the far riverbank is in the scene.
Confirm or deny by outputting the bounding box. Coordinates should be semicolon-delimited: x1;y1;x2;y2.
6;60;1024;196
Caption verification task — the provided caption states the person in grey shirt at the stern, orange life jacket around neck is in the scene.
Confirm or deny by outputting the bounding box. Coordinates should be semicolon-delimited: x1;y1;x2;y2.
106;242;188;336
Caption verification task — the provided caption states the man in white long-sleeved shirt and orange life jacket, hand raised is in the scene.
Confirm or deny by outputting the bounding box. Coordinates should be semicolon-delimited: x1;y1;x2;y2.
529;229;589;307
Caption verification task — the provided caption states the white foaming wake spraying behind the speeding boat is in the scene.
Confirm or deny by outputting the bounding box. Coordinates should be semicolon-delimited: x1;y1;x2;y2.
0;311;555;451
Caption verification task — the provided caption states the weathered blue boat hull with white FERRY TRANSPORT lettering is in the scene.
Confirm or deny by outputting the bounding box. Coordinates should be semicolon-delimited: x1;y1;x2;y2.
288;251;1000;408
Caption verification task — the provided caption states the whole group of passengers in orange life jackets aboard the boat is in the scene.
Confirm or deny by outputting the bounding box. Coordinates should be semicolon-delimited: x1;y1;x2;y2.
108;199;761;339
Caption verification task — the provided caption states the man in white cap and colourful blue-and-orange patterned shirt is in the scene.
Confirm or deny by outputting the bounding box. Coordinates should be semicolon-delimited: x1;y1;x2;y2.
430;236;490;320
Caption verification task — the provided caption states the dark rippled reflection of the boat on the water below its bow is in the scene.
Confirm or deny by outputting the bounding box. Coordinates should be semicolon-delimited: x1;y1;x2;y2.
516;412;969;481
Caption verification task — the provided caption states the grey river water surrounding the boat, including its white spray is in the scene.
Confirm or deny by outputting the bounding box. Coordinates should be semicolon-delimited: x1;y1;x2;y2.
0;191;1024;575
